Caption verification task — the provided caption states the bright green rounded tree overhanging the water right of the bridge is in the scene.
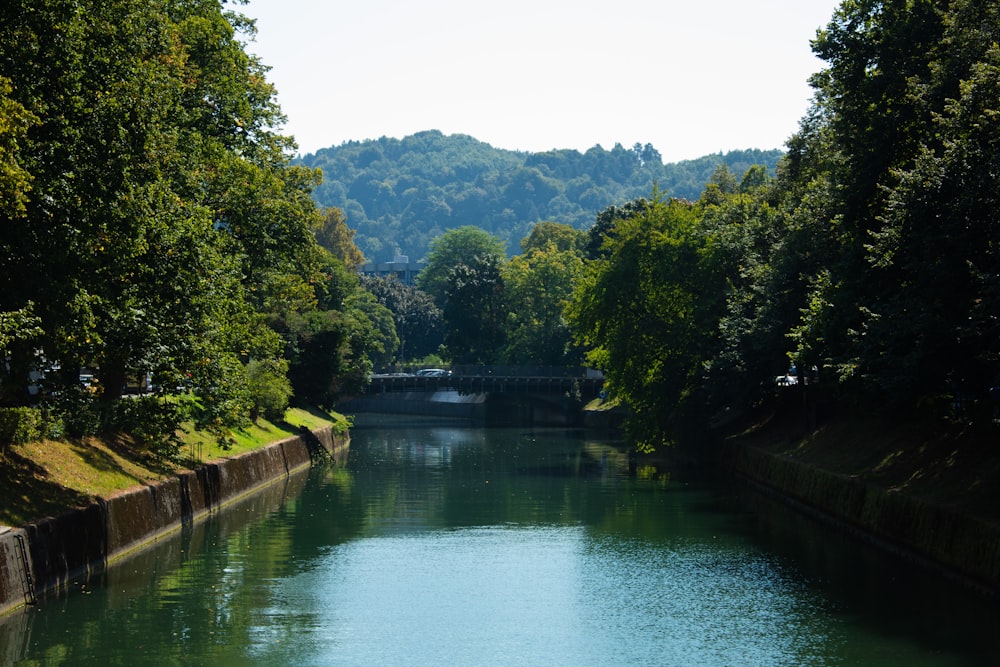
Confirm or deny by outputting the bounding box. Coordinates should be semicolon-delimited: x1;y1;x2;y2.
567;196;723;447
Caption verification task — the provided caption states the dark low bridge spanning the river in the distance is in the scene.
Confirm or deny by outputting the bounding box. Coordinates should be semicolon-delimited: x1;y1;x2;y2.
366;366;604;397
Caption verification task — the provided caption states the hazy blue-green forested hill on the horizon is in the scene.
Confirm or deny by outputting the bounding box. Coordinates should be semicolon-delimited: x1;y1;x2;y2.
298;130;783;262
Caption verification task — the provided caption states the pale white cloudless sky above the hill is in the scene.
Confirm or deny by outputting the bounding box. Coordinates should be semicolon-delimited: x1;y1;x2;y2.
235;0;839;162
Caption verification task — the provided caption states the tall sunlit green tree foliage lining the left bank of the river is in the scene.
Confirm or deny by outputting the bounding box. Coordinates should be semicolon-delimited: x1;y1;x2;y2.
0;0;389;448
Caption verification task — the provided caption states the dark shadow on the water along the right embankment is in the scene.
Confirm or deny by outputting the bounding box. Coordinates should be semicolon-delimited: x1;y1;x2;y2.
704;476;1000;665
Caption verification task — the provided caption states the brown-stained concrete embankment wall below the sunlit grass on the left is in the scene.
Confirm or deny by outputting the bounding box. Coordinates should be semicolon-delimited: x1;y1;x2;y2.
0;428;346;614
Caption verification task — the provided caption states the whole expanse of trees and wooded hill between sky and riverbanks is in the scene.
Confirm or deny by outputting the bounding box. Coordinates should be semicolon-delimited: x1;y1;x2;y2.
0;0;1000;454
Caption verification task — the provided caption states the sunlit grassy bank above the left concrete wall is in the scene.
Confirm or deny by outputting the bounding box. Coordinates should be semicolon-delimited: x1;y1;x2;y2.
0;408;348;526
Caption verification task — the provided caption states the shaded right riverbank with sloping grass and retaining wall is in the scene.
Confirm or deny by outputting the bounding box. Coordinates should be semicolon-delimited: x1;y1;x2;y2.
717;404;1000;598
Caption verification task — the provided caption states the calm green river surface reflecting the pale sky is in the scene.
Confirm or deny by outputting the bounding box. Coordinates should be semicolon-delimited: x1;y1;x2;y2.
0;424;1000;667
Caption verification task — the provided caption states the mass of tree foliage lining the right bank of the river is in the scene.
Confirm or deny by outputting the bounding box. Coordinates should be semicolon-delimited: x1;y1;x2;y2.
569;0;1000;442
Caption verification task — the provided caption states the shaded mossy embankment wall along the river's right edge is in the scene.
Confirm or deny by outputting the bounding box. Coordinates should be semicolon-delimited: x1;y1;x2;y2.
723;443;1000;597
